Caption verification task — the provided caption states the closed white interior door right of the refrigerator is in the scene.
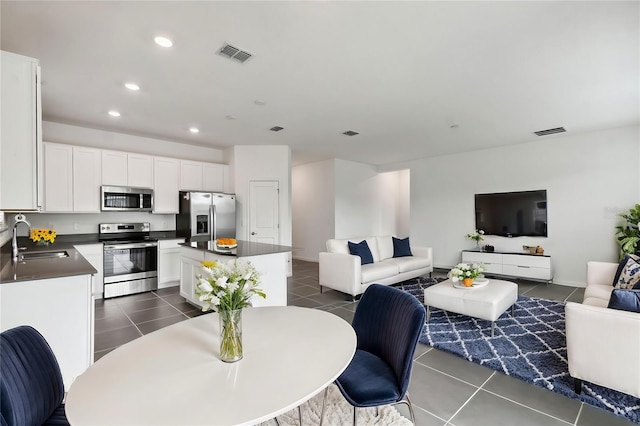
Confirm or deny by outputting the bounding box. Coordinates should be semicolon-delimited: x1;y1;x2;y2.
249;181;280;244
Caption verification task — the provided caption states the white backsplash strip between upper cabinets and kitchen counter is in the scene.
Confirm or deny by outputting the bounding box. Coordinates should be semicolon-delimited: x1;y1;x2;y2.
6;212;176;236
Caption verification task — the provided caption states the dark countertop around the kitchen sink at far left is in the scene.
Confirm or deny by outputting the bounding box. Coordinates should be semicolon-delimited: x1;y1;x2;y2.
0;248;97;284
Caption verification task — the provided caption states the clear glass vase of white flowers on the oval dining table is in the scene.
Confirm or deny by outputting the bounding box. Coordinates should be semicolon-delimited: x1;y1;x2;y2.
195;259;266;362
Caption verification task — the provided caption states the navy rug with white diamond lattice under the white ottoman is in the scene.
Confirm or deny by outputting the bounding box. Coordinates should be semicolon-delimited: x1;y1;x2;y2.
395;277;640;424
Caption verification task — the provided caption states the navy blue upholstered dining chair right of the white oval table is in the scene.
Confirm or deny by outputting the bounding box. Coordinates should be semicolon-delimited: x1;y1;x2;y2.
321;284;426;425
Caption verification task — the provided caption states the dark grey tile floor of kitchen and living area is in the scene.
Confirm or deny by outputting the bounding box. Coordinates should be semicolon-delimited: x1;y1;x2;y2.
95;260;634;426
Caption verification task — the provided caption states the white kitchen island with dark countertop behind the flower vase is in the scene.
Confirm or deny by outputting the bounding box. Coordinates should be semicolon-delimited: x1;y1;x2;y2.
180;240;292;306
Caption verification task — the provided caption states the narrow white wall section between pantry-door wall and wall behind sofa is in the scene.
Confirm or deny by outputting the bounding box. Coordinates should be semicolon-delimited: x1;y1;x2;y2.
291;160;335;262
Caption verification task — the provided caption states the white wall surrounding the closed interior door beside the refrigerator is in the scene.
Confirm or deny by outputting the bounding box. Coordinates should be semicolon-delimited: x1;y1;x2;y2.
228;145;292;246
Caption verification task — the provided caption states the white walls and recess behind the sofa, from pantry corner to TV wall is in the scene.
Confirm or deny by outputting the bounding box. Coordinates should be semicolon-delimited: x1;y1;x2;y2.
292;159;410;262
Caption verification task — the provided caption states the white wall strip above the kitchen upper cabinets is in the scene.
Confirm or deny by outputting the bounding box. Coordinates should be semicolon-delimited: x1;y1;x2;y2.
42;121;224;163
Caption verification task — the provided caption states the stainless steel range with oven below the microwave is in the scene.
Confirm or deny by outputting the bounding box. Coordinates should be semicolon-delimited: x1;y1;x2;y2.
98;223;158;299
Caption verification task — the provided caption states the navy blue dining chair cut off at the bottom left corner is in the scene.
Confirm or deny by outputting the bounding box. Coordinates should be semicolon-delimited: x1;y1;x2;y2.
0;325;69;426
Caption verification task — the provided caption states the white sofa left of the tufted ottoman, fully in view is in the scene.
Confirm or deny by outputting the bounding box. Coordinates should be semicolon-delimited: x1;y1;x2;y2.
319;235;433;298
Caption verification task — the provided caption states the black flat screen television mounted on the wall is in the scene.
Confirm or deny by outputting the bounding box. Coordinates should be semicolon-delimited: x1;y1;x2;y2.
475;190;547;237
